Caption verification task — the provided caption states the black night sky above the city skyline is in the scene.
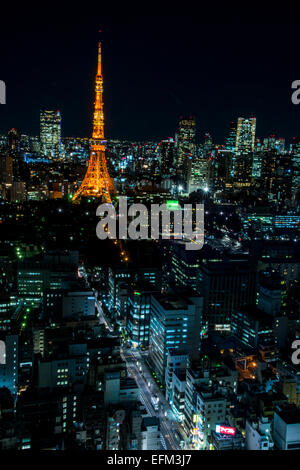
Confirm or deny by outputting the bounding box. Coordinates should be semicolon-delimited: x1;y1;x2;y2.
0;13;300;143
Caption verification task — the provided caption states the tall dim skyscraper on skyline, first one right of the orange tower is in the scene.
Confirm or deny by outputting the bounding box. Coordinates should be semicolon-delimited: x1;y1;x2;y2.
176;116;196;175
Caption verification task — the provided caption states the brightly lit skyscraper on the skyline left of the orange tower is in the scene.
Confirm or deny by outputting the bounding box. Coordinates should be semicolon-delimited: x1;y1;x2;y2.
40;110;61;158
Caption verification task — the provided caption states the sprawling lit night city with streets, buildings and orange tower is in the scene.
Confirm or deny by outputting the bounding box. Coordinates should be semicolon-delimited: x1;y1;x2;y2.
0;16;300;454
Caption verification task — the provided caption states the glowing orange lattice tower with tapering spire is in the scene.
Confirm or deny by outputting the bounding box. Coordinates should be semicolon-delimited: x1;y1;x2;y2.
72;42;115;202
